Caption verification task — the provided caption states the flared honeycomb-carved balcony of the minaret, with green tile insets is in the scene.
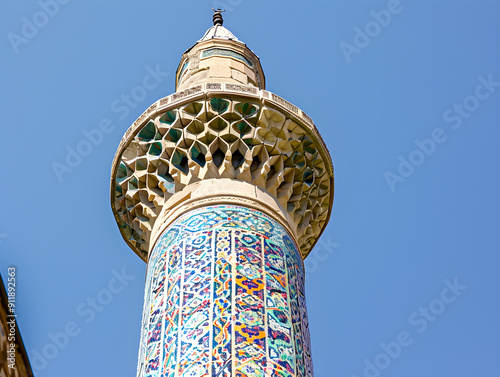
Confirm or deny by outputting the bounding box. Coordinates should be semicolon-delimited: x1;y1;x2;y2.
111;83;333;260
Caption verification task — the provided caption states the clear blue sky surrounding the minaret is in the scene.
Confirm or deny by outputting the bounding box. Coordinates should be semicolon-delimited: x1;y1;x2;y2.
0;0;500;377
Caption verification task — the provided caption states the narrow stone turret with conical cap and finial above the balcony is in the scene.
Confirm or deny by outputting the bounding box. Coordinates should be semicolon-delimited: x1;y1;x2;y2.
176;10;266;91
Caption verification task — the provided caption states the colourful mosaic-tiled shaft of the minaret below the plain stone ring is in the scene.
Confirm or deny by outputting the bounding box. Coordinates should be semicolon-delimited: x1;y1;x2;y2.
138;205;313;377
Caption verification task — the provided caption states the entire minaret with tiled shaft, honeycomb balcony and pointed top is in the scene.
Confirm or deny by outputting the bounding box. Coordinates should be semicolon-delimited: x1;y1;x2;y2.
111;10;333;377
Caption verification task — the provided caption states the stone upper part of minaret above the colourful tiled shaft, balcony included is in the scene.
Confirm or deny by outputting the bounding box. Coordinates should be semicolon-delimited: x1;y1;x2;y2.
111;16;333;261
